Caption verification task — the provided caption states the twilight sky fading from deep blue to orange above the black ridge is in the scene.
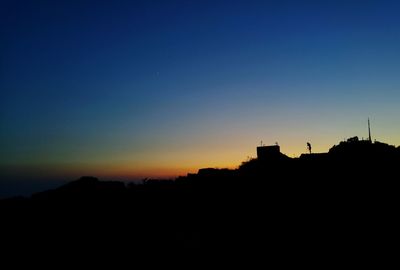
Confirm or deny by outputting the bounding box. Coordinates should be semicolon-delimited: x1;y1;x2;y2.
0;0;400;196
